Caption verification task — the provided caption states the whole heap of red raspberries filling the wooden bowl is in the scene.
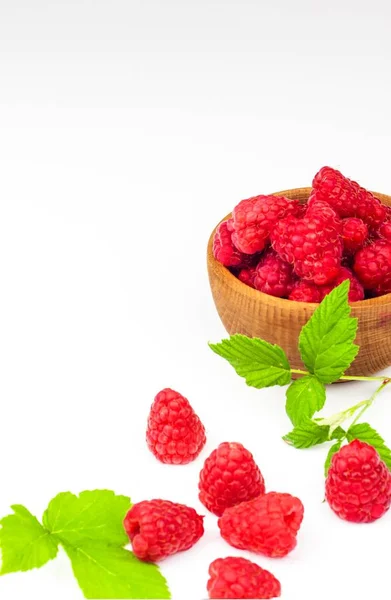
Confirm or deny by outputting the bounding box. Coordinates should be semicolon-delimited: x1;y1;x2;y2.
213;167;391;302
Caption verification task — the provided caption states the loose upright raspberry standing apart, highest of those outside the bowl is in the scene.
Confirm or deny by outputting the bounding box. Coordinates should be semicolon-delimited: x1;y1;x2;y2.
147;388;206;465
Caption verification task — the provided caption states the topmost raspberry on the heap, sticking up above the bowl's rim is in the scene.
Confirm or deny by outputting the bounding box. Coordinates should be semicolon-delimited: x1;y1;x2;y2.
312;167;386;229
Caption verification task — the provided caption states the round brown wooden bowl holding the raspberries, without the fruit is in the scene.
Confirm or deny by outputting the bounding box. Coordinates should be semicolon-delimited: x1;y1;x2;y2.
207;188;391;375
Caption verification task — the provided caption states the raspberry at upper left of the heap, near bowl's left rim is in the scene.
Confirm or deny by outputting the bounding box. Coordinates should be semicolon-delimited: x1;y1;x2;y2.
232;196;299;254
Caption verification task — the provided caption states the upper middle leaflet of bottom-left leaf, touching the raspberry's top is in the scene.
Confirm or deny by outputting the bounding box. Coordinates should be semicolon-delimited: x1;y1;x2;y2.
43;490;131;546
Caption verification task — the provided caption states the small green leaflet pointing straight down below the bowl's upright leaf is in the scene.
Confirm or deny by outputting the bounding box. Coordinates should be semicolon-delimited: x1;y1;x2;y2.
285;375;326;425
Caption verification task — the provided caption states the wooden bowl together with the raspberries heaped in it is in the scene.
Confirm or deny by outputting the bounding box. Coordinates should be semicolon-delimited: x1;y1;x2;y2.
208;167;391;375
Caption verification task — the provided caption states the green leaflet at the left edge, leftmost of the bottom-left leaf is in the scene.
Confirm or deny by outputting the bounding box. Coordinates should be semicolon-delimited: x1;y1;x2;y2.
0;505;58;575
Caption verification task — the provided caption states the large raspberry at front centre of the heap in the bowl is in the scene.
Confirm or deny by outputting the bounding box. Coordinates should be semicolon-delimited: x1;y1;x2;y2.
271;201;342;285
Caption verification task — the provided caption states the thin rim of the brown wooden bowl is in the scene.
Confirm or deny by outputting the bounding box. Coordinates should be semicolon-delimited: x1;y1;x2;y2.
207;187;391;312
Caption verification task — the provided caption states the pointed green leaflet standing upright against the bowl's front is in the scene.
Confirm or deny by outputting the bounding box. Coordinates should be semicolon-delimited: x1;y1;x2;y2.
299;280;358;383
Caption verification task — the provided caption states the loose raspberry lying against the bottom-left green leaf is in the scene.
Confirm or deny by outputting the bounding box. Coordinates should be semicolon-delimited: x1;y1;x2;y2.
124;500;204;562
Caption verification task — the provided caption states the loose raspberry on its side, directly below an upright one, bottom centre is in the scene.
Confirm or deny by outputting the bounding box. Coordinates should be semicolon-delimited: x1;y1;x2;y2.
218;492;304;557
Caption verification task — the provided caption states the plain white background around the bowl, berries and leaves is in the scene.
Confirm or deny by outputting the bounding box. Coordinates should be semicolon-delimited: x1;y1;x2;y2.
0;0;391;600
